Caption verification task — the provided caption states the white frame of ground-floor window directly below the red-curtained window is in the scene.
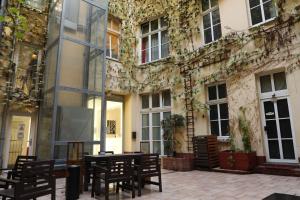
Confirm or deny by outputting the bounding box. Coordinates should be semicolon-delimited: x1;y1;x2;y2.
140;91;172;155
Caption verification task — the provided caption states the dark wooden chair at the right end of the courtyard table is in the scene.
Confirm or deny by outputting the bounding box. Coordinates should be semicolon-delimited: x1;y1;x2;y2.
136;154;162;196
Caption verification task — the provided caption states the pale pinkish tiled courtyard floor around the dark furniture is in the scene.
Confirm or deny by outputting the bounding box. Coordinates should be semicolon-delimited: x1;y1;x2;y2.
41;171;300;200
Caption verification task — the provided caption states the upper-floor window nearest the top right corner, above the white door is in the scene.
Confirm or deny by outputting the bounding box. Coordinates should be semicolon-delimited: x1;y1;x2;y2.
249;0;276;25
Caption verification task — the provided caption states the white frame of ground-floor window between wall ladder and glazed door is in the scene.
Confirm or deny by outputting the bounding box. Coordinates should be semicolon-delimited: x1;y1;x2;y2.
206;82;230;141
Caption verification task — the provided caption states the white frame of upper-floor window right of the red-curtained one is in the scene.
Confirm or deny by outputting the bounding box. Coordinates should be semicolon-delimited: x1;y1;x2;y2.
201;0;222;45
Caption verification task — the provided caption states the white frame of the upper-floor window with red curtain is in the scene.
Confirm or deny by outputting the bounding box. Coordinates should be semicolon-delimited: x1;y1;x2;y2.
139;17;170;64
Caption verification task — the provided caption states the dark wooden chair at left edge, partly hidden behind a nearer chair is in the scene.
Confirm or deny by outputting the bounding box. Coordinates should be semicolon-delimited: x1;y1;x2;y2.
0;156;37;189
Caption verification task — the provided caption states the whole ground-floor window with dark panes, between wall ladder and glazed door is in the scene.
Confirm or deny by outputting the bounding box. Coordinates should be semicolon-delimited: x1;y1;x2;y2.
208;84;229;137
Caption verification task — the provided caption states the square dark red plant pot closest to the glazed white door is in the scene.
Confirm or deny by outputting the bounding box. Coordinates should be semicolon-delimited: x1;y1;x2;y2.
234;152;256;171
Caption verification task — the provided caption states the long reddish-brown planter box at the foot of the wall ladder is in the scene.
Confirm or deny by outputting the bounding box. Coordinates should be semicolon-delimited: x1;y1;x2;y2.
162;157;193;171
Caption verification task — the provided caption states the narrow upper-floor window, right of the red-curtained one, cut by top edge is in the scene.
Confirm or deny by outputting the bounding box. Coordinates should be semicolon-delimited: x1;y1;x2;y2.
202;0;222;44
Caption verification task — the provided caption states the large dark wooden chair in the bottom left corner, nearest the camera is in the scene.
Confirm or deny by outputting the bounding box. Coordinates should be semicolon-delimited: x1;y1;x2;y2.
0;160;55;200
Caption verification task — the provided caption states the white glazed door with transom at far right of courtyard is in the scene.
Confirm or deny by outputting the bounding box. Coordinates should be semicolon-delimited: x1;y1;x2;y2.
260;72;298;163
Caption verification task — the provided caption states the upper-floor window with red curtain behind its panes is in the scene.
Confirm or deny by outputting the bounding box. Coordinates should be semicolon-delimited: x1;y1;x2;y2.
141;17;169;63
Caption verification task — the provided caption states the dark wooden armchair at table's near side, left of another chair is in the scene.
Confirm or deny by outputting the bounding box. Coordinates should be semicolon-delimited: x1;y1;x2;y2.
91;156;135;200
